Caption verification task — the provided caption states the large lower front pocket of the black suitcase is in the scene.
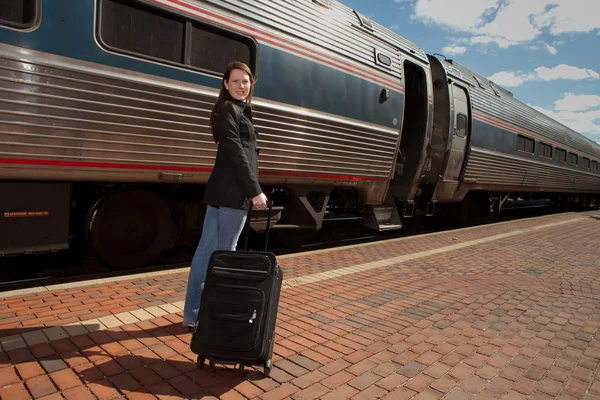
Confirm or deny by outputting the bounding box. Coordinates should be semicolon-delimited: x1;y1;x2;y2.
198;285;264;352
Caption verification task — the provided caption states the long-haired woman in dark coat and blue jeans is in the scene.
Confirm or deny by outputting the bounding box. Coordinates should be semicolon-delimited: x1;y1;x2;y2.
183;62;267;327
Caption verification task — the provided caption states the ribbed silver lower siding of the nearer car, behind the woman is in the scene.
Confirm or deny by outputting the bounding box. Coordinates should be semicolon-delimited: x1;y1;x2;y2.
0;50;398;185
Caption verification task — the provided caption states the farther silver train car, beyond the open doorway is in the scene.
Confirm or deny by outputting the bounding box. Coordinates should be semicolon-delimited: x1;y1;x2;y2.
422;56;600;219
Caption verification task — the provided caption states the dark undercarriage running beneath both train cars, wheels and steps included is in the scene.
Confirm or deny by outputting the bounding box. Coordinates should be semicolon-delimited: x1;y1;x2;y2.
0;182;596;269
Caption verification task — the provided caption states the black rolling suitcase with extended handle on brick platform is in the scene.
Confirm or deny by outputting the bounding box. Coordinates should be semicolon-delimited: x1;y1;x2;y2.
190;203;283;376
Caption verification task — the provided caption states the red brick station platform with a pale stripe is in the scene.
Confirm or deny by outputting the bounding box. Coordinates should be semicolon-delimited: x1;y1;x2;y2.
0;213;600;400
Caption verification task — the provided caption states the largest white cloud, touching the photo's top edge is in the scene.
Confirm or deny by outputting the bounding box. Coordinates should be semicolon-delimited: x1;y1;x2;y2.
410;0;600;54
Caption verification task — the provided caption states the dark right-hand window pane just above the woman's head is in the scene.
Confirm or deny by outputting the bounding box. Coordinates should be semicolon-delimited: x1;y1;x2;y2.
190;26;251;72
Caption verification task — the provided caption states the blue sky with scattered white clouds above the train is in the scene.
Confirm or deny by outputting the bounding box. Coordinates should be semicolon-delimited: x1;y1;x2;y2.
339;0;600;143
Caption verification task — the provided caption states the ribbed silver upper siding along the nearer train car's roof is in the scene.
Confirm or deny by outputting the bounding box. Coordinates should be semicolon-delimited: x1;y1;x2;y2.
202;0;428;77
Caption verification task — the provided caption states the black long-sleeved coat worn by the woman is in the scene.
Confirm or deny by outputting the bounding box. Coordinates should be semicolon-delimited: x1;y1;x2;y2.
204;100;262;210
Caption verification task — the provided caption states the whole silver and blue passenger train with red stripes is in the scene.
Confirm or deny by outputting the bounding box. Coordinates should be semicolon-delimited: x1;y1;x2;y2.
0;0;600;268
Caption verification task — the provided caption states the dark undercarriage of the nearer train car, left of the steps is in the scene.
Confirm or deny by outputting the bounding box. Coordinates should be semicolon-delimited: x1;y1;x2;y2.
0;182;332;269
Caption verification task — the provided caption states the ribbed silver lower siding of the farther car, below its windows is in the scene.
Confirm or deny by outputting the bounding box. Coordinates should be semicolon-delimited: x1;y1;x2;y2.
464;147;600;192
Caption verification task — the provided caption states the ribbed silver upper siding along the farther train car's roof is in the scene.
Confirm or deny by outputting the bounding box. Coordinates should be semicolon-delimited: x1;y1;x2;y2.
442;61;600;159
